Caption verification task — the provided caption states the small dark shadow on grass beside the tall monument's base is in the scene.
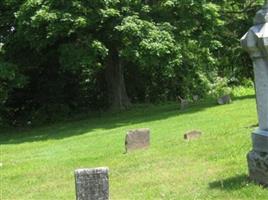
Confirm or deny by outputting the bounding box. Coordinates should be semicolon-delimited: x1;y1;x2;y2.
209;174;250;190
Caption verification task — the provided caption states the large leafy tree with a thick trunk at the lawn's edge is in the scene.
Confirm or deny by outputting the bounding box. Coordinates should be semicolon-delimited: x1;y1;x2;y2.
4;0;180;109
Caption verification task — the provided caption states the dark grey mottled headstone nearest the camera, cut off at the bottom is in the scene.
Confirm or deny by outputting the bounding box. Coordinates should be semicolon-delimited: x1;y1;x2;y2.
75;168;109;200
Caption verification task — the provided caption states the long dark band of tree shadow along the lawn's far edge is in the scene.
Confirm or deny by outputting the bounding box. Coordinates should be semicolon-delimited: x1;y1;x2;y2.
0;97;255;144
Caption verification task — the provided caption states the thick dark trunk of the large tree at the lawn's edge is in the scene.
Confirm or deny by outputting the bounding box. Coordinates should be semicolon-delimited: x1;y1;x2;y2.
105;49;131;110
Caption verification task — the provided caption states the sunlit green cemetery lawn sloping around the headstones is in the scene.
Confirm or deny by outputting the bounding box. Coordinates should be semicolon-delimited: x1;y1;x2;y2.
0;89;268;200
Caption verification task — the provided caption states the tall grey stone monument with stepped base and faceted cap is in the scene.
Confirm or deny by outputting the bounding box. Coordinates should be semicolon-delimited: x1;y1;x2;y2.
241;0;268;185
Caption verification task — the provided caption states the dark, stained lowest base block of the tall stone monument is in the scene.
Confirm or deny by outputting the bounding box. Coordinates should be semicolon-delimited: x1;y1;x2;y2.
247;151;268;185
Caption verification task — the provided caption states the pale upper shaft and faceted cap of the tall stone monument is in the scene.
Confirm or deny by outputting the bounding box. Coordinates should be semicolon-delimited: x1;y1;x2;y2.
241;2;268;130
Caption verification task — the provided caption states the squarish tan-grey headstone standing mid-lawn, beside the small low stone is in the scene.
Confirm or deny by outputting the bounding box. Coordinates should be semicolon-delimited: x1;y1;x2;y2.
125;128;150;152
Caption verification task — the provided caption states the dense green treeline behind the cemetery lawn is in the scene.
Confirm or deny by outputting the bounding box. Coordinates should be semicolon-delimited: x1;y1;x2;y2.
0;0;263;124
